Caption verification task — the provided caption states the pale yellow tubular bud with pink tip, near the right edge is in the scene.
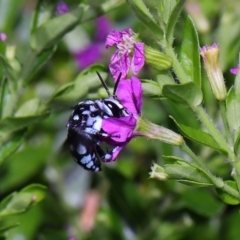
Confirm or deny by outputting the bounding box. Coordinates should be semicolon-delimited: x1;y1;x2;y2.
200;43;227;101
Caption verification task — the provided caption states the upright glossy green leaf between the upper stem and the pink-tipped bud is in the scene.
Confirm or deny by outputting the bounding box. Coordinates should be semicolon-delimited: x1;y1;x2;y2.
179;16;201;88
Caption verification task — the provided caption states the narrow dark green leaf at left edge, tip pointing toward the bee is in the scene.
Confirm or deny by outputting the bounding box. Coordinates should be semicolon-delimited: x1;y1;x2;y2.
0;113;49;138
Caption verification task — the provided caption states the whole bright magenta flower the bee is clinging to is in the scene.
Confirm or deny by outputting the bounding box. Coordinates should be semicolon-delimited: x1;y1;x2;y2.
102;76;143;162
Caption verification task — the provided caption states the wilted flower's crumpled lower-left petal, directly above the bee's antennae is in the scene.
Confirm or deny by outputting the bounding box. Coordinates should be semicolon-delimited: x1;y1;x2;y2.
109;51;131;81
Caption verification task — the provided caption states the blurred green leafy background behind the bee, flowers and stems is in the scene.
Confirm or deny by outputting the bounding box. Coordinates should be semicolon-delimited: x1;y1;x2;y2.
0;0;240;240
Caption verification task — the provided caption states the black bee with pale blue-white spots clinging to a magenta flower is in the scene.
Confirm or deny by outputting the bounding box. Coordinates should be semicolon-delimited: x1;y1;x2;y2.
67;72;129;172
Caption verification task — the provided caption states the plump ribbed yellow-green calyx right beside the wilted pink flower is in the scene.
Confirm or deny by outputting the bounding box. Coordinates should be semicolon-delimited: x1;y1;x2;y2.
144;45;172;71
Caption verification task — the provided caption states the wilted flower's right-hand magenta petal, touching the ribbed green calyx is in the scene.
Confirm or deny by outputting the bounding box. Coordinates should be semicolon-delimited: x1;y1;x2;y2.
131;43;145;75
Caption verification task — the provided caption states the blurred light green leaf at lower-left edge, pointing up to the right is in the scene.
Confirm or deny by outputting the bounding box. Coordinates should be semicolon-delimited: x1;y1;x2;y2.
0;184;46;217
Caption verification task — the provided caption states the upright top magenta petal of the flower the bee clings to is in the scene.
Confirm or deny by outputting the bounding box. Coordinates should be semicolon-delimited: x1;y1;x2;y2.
117;76;143;115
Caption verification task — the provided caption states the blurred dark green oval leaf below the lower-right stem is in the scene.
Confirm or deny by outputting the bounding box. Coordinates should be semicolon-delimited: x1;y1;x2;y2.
181;188;224;217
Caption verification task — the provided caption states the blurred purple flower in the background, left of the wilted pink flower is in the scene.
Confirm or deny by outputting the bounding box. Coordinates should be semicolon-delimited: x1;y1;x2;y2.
74;16;110;69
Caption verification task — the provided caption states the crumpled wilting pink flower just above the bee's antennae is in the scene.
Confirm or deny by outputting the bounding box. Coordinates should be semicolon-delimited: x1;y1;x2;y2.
106;28;145;81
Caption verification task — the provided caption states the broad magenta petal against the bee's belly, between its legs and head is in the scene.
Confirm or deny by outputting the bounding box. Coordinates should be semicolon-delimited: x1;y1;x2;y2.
102;116;137;143
